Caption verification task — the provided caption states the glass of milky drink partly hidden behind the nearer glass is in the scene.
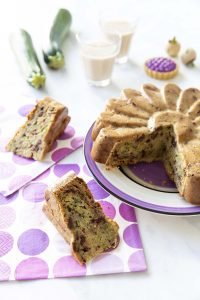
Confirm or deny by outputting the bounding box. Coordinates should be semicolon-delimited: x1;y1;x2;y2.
100;13;137;64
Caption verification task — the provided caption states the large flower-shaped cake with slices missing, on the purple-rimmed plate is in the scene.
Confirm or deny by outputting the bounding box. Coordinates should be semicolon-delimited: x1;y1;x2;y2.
91;83;200;204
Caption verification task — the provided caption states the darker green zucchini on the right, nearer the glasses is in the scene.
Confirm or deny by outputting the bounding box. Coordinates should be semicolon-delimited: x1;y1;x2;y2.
43;8;72;69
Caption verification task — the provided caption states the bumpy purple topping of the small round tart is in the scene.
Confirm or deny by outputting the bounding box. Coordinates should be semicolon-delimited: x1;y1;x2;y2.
146;57;176;73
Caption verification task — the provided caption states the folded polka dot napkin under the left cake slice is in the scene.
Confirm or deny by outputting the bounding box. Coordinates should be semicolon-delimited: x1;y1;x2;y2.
0;96;83;196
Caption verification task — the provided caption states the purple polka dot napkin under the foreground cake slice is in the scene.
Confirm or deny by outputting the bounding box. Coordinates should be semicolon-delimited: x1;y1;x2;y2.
0;150;146;281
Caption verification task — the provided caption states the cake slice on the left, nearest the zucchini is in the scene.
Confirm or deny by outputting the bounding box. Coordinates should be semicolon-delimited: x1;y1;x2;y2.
6;97;70;160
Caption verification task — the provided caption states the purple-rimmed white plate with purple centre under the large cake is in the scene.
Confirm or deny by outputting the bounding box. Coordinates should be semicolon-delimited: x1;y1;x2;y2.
84;125;200;215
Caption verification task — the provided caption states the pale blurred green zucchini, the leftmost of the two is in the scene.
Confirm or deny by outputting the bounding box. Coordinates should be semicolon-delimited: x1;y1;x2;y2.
10;29;46;89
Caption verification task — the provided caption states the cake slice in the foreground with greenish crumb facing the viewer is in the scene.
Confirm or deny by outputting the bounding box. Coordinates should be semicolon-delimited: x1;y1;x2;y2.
43;172;118;264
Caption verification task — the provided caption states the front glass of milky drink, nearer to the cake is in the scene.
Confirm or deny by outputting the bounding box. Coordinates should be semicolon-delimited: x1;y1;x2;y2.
76;32;120;87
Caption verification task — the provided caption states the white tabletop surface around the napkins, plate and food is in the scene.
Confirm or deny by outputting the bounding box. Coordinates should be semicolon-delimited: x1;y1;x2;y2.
0;0;200;300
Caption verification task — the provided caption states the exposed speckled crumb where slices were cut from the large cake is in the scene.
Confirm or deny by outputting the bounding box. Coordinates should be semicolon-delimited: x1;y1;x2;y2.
104;126;185;189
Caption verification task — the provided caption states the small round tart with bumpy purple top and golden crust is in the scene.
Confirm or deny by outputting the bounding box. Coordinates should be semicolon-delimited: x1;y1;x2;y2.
144;57;178;80
